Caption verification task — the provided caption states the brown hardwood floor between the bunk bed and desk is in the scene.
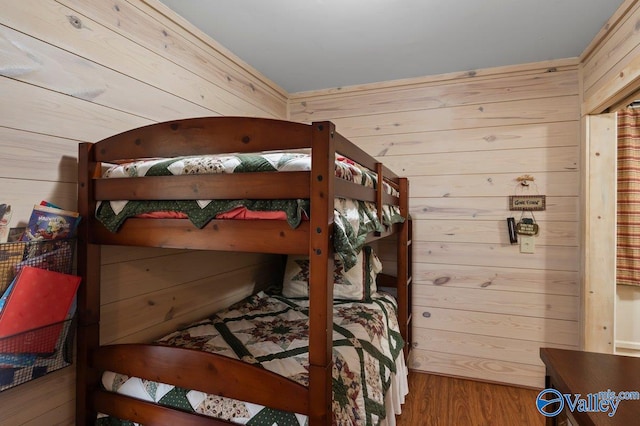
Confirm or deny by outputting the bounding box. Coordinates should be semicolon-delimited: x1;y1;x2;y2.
397;371;546;426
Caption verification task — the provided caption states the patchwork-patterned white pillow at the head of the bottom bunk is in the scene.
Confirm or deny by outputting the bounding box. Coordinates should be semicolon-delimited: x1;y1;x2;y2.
282;246;382;302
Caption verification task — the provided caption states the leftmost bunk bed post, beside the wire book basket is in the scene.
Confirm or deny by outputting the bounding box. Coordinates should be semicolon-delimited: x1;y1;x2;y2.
75;143;100;425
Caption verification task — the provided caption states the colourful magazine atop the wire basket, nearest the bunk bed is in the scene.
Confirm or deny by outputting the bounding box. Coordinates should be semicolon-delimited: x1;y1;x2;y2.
22;205;80;241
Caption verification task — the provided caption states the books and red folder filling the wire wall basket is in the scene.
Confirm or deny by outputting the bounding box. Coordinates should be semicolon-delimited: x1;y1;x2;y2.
0;201;81;368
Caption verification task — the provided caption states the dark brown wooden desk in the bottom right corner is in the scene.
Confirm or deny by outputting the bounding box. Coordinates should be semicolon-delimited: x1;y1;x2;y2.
540;348;640;426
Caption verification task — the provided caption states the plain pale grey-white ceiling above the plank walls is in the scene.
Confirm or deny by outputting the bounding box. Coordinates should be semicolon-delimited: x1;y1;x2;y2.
161;0;623;93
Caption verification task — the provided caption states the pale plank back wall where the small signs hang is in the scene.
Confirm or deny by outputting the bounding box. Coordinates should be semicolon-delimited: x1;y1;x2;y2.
290;59;580;388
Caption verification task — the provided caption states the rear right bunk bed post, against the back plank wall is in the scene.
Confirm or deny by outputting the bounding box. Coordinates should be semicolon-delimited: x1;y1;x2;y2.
396;178;413;357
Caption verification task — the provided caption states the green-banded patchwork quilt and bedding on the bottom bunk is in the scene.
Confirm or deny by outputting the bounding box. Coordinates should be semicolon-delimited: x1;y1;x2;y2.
96;292;407;426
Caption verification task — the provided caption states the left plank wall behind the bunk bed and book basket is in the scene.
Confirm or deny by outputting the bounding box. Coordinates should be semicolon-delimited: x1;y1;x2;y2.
0;0;287;425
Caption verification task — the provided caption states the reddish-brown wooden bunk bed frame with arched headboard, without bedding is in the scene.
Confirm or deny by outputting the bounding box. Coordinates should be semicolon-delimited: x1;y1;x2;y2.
76;117;411;426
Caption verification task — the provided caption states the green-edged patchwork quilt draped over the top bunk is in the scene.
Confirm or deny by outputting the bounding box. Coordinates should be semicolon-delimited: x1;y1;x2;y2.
96;153;404;269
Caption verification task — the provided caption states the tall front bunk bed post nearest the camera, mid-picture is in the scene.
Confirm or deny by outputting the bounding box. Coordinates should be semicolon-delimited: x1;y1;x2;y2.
309;122;335;426
